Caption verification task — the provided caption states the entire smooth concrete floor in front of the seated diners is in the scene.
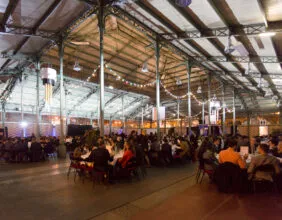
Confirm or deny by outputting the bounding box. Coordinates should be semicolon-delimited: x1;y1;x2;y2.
0;161;282;220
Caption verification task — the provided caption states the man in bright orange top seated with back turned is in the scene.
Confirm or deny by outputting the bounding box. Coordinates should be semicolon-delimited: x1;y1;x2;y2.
218;138;248;169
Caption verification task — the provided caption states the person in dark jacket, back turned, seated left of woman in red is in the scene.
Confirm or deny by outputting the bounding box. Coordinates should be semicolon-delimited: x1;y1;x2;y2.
87;140;110;172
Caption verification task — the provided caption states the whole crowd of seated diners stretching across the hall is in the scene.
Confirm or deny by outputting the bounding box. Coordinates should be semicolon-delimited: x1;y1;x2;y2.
0;131;282;192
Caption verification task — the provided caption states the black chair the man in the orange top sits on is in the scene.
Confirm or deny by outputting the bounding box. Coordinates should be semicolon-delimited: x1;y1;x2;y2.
214;162;243;193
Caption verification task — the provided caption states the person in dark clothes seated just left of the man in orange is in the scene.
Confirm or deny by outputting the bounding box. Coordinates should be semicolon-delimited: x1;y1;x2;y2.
198;140;218;171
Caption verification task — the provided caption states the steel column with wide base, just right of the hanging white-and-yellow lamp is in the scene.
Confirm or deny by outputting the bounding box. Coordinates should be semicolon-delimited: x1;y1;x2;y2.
58;36;66;158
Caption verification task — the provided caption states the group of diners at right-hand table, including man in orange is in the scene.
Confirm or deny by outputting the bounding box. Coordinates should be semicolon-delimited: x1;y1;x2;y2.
198;136;282;191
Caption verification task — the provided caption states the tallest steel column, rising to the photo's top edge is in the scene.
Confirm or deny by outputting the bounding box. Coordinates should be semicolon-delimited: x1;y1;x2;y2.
98;3;105;137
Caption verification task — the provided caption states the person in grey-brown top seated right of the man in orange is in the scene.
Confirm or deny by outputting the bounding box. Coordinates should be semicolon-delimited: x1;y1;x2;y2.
248;144;280;181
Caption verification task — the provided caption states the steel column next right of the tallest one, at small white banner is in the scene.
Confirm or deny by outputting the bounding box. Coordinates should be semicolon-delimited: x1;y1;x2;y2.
155;38;161;144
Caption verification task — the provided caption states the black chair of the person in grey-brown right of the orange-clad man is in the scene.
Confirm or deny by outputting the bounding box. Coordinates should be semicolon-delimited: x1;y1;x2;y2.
251;164;277;193
